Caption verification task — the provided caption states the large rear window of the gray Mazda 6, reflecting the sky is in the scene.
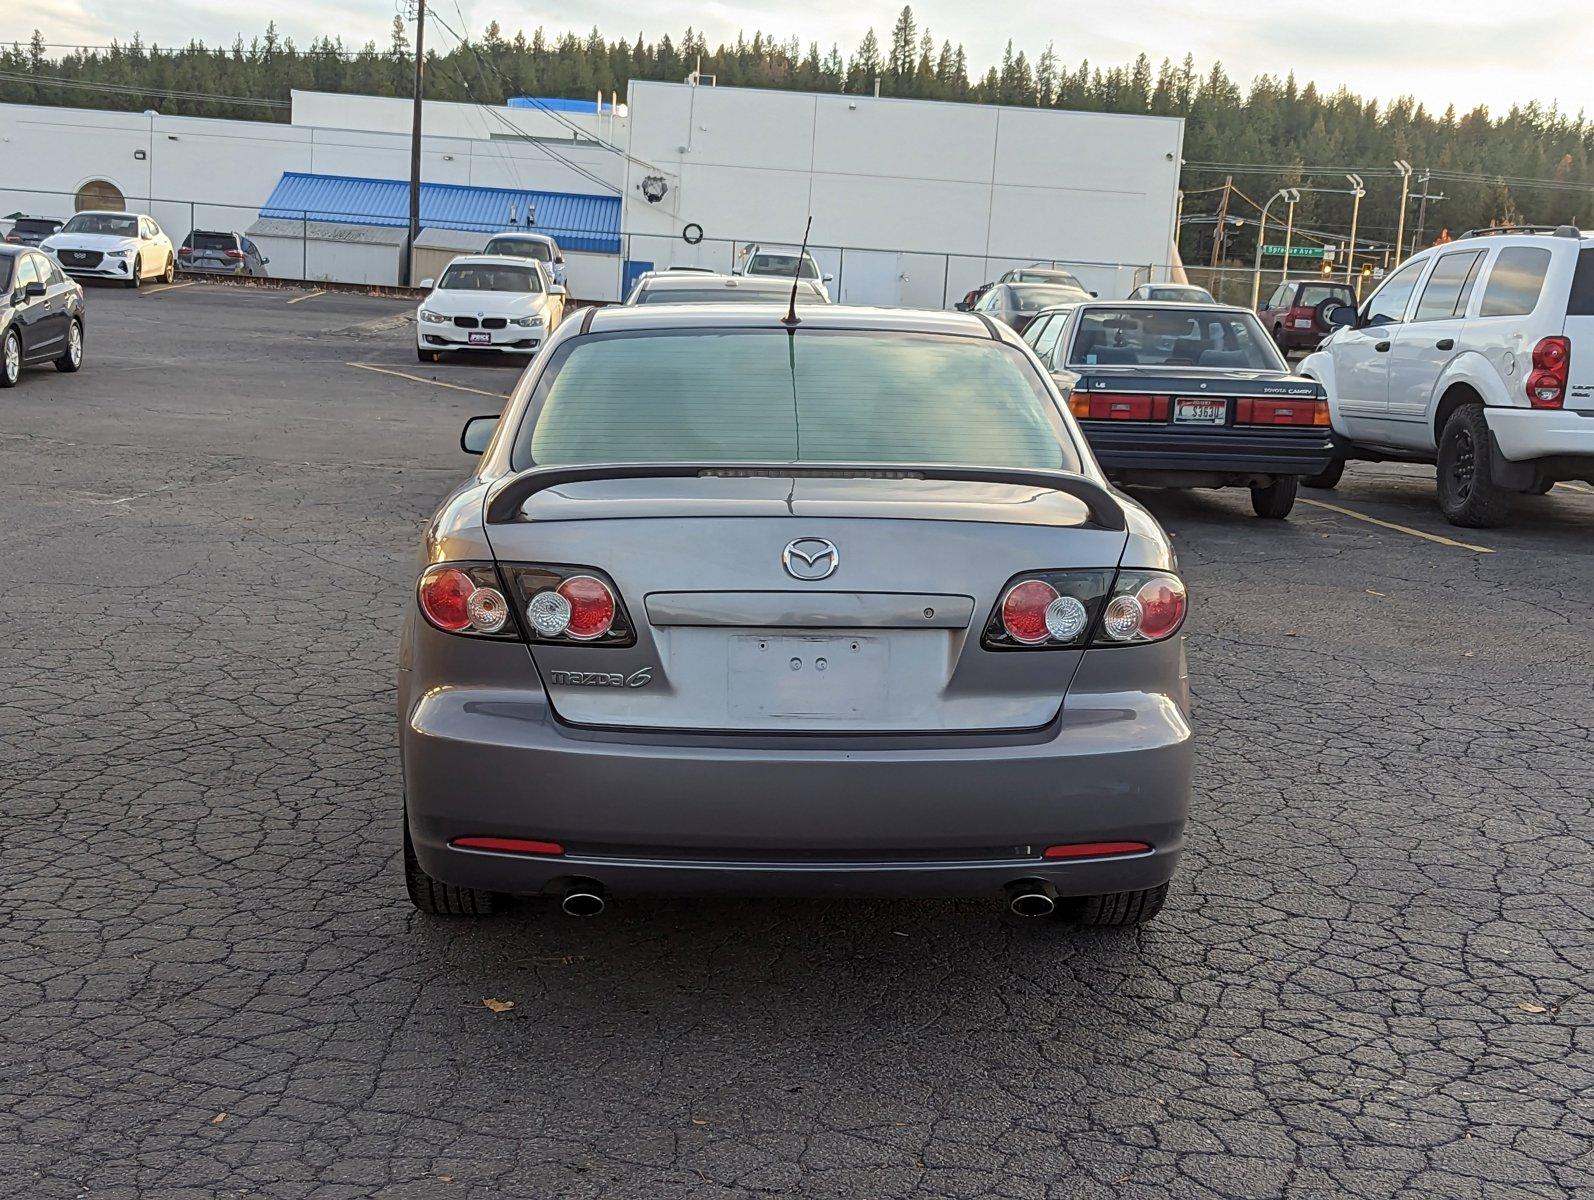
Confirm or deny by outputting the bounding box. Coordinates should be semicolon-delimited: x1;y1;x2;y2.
513;330;1081;470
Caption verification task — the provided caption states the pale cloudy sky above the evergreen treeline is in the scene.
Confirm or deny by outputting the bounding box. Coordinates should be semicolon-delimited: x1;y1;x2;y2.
12;0;1594;113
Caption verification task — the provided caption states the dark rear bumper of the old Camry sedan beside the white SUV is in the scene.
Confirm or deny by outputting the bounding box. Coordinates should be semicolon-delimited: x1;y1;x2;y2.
1079;421;1336;475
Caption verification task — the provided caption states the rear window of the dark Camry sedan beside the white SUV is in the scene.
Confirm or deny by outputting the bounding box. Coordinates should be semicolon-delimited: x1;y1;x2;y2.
1068;304;1285;371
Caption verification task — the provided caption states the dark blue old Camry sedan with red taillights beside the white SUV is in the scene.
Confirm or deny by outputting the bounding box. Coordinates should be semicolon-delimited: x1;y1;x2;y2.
1052;301;1336;518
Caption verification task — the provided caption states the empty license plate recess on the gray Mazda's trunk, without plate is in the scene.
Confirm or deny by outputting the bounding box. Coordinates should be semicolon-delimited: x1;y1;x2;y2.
727;634;891;719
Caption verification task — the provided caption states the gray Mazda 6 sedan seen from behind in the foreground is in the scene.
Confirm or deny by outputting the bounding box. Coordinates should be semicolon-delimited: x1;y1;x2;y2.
399;304;1191;924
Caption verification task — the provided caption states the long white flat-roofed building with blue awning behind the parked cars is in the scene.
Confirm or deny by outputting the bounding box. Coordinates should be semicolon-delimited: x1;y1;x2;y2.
0;81;1183;308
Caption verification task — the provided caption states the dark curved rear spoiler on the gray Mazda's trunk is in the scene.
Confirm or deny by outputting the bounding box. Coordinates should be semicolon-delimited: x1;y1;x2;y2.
486;462;1129;531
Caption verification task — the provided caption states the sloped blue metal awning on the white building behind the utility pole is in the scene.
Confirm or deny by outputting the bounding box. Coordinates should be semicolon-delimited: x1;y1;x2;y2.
260;171;620;253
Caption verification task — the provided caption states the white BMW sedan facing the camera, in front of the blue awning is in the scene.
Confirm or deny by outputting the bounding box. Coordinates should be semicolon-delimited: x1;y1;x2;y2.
414;255;564;362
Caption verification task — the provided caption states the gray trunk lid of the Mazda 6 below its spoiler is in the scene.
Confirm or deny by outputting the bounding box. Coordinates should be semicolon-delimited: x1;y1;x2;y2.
488;475;1127;733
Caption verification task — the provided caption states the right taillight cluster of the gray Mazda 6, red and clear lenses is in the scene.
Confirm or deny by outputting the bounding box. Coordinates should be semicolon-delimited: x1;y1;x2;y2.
980;571;1186;650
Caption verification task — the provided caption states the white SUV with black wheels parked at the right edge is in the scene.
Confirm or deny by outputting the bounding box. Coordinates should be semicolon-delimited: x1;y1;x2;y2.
1301;226;1594;526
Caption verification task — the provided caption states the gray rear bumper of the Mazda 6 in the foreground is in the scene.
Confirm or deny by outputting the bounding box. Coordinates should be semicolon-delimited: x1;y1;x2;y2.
400;644;1191;896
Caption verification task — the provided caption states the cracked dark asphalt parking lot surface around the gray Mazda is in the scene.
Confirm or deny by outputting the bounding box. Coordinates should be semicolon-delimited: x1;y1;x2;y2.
0;275;1594;1200
